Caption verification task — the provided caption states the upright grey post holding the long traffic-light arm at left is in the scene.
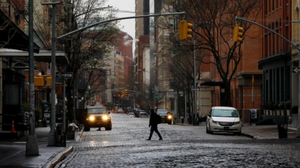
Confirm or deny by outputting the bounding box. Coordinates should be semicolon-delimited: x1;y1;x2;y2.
48;0;56;146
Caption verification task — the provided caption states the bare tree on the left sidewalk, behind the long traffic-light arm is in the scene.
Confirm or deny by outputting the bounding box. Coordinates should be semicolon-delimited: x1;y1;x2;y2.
57;0;119;119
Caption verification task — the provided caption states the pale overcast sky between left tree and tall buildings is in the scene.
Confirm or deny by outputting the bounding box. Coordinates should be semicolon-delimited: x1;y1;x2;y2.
105;0;135;57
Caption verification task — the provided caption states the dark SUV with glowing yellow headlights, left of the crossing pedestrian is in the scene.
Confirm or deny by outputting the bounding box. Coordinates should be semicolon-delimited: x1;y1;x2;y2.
84;106;112;131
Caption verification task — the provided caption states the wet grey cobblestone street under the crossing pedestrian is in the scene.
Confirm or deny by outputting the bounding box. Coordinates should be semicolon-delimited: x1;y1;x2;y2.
55;114;300;168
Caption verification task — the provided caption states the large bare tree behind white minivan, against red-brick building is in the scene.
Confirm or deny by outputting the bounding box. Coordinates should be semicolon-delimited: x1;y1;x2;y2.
174;0;261;105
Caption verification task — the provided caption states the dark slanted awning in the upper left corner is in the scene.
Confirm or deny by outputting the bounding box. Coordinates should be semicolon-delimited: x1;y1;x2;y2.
0;10;40;53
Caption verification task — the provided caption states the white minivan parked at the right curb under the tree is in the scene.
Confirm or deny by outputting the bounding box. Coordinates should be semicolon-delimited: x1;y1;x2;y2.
206;106;242;134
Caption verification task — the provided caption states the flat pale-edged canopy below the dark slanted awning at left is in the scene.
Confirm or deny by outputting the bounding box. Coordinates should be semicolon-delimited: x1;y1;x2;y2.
0;48;69;64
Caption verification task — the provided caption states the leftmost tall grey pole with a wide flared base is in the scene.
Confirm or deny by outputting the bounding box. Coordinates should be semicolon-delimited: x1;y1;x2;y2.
26;0;39;156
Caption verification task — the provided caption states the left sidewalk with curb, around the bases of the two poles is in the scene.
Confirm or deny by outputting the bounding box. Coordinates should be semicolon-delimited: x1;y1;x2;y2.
0;126;83;168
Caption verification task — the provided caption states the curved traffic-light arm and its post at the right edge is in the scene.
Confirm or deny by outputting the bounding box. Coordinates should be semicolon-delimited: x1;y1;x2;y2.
235;15;300;137
